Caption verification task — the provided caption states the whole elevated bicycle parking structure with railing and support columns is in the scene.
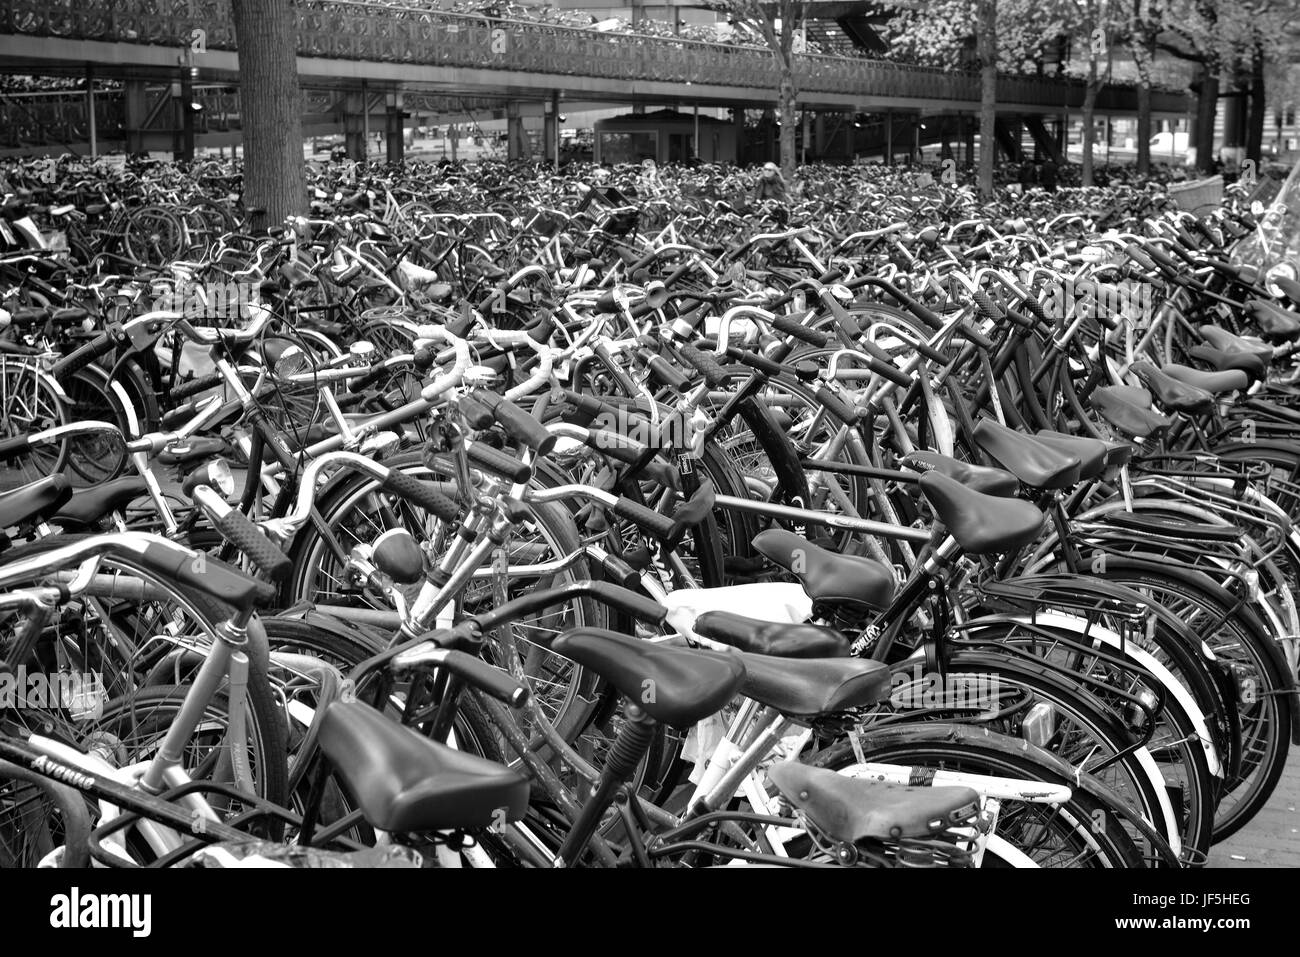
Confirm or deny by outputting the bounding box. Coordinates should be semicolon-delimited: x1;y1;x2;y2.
0;0;1188;156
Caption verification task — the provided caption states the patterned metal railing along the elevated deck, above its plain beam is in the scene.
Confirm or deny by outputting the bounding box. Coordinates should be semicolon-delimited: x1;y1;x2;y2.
0;0;1178;109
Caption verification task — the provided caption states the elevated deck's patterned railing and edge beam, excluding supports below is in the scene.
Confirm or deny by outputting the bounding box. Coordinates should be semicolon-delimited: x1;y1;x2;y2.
0;0;1187;114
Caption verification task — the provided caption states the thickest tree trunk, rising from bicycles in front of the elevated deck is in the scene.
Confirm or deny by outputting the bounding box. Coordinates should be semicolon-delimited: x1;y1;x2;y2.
231;0;307;229
